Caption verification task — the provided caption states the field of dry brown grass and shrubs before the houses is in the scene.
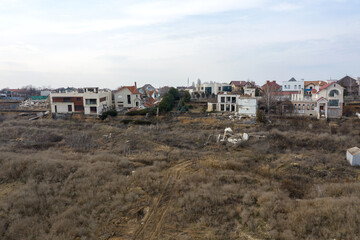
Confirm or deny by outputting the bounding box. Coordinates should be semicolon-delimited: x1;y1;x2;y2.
0;117;360;240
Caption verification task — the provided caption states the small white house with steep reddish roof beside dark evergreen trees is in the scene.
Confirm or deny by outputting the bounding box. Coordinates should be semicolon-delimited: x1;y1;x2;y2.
114;83;141;111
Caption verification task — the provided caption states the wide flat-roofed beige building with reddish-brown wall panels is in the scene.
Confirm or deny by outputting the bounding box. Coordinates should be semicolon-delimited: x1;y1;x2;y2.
50;87;112;115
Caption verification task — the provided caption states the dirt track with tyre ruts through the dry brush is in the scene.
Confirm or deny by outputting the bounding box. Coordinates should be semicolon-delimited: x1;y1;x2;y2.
134;160;194;240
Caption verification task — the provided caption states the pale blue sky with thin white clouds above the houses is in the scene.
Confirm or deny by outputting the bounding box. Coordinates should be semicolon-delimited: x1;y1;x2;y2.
0;0;360;89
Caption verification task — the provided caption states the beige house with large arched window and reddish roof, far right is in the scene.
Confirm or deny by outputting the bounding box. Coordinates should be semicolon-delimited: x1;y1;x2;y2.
291;82;344;119
